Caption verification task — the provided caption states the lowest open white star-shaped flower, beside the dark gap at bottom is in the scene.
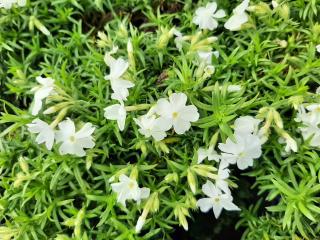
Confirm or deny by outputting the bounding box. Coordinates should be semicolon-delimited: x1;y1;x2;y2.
197;181;240;218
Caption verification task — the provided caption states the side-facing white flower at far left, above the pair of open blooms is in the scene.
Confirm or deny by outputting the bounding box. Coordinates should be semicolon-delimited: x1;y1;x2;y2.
31;76;55;115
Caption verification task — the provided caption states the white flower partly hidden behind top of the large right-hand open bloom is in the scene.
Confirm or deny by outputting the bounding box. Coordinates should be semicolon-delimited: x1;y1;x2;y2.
234;116;261;134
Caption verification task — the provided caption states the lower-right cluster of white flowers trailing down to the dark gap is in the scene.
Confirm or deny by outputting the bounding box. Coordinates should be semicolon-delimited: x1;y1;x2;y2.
197;116;262;218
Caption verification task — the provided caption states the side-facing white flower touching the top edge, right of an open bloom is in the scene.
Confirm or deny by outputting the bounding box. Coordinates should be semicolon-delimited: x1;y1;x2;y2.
224;0;250;31
